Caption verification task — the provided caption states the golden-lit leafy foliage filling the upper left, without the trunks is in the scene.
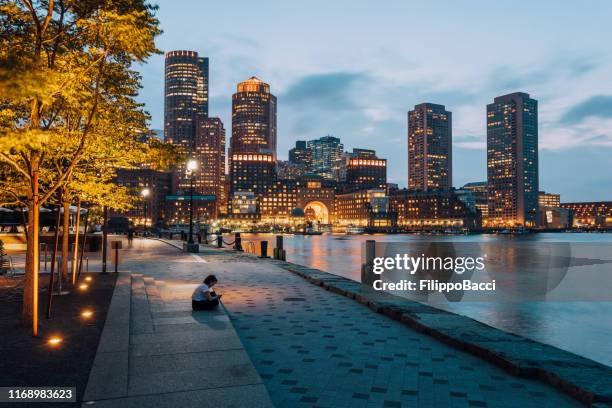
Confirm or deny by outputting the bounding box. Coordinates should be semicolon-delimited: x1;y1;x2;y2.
0;0;179;209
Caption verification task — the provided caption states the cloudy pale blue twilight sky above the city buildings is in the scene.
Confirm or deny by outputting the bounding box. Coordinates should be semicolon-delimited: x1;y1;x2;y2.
138;0;612;201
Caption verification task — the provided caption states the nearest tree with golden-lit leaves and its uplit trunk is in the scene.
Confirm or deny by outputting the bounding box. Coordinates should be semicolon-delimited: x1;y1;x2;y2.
0;0;160;336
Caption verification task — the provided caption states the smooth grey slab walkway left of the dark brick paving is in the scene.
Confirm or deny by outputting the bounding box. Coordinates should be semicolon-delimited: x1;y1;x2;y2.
83;240;272;407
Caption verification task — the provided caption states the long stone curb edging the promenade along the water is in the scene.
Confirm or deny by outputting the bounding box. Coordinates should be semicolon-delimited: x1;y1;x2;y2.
153;239;612;408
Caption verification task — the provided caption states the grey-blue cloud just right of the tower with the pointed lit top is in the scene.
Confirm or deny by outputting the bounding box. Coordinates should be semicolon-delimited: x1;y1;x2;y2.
279;72;367;109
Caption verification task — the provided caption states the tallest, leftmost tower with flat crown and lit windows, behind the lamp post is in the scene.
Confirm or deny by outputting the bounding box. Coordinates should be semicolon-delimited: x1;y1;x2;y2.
164;51;209;195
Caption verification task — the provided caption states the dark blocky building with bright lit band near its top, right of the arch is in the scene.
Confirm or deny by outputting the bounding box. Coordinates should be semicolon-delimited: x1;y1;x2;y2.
343;149;387;192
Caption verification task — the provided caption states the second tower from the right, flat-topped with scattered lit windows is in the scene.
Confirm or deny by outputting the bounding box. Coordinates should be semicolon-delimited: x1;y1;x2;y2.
408;103;453;191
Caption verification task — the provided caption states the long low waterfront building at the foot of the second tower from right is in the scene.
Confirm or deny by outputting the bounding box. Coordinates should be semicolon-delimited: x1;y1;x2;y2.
390;189;481;230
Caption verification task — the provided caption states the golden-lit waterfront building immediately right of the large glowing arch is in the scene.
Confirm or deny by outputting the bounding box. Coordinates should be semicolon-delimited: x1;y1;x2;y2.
335;189;396;230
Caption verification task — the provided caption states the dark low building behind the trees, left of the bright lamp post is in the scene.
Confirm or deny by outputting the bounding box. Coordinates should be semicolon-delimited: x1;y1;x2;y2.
110;168;173;227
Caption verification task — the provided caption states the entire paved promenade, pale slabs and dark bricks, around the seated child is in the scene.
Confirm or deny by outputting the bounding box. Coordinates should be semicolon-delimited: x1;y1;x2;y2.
81;240;580;408
